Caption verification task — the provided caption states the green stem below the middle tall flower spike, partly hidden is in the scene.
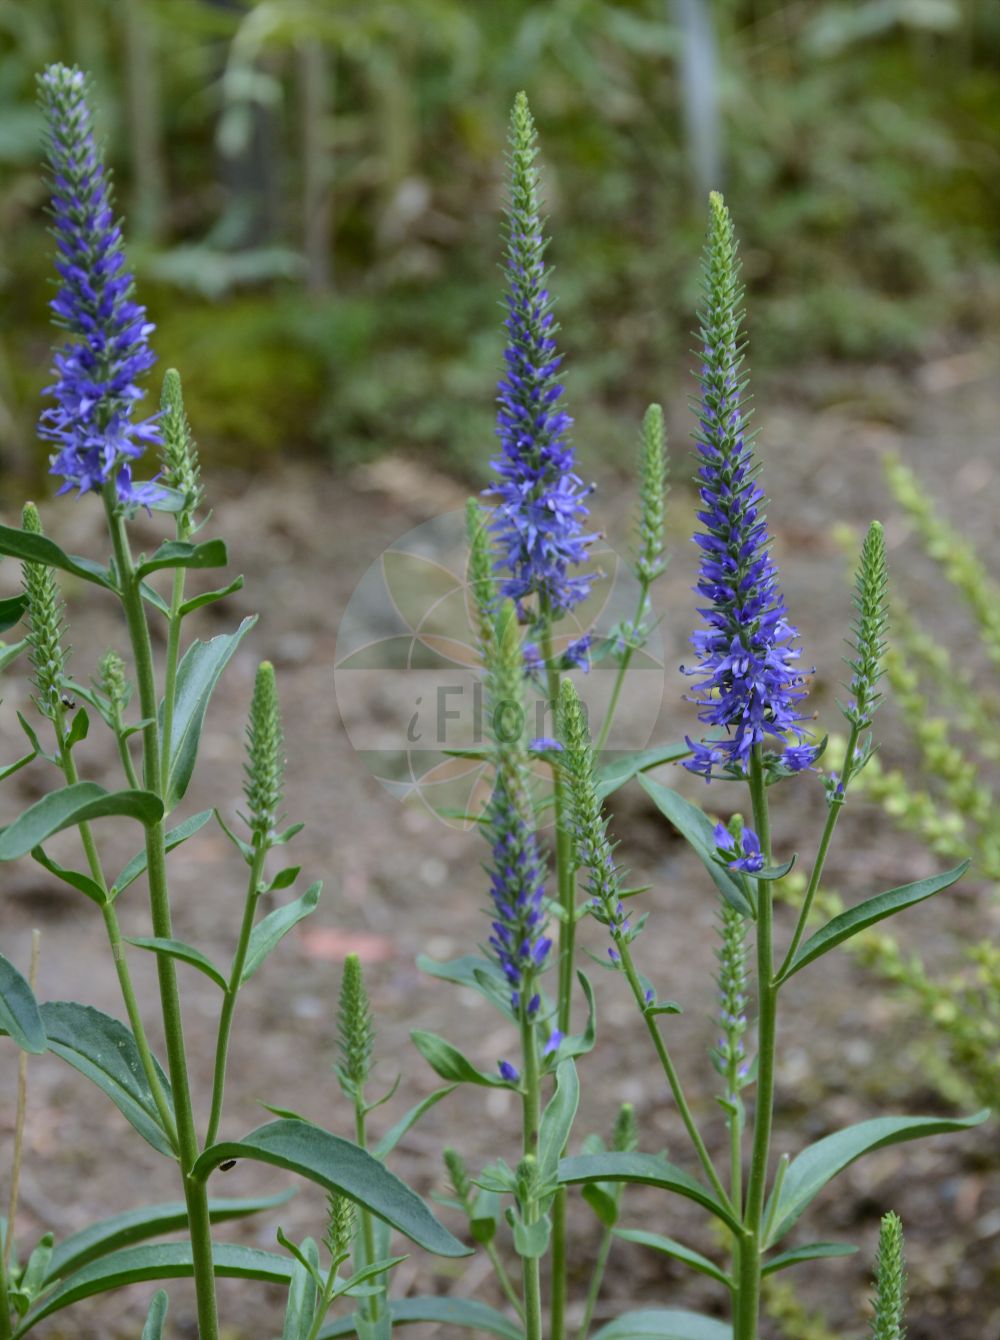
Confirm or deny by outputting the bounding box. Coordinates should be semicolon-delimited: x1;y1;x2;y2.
542;611;576;1340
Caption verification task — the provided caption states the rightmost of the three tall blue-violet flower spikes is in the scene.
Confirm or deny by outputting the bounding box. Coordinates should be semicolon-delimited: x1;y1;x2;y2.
685;192;806;780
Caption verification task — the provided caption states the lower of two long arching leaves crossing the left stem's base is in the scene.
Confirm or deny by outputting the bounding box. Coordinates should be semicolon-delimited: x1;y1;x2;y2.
13;1242;292;1340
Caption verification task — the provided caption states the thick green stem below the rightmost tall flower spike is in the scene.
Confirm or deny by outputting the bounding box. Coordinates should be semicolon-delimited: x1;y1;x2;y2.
733;745;777;1340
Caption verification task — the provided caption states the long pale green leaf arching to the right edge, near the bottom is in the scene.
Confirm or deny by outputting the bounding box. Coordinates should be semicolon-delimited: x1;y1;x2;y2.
764;1110;989;1248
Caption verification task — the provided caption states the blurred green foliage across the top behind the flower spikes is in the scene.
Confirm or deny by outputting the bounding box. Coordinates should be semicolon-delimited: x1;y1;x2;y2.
0;0;1000;485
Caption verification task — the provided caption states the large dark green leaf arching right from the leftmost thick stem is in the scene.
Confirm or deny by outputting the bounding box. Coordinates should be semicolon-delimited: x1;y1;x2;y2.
190;1120;469;1256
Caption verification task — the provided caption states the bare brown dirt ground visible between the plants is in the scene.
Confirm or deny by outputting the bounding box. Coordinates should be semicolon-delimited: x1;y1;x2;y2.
0;355;1000;1340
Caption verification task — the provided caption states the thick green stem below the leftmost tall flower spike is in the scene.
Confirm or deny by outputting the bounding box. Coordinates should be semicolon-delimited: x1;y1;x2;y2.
105;484;218;1340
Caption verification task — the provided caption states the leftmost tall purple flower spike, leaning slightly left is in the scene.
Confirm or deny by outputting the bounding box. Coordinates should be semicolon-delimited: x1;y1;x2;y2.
39;66;162;505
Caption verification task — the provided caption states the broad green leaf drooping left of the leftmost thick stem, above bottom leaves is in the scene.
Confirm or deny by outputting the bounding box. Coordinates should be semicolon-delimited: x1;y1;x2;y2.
40;1001;174;1158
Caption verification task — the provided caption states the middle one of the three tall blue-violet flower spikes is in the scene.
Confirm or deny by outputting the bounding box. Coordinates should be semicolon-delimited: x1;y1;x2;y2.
488;92;595;619
